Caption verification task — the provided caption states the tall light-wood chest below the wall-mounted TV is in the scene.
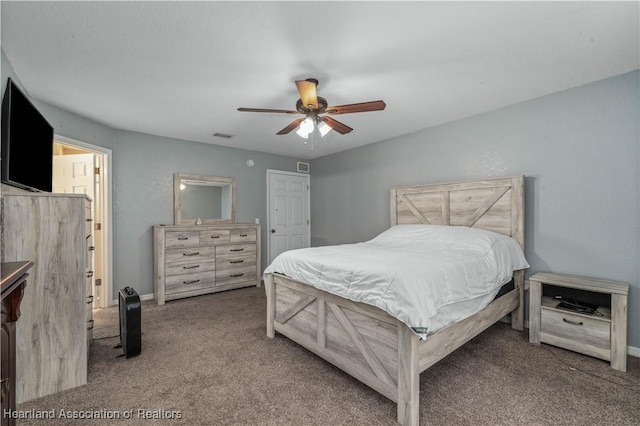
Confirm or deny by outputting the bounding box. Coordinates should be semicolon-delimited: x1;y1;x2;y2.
2;193;93;403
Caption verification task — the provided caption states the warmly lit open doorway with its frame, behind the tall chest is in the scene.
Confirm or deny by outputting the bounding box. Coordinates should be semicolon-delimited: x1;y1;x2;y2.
52;136;113;308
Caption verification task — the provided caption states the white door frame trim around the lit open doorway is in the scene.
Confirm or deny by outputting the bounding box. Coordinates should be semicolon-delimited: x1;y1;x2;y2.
54;134;113;308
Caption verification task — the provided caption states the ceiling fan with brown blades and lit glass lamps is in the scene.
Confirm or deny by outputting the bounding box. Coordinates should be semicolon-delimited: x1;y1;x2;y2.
238;78;387;139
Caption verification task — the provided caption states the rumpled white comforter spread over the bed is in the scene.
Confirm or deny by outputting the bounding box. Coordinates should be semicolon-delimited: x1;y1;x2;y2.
265;225;529;338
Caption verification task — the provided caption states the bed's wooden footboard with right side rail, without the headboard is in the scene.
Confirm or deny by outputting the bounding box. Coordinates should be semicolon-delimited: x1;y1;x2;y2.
264;274;522;425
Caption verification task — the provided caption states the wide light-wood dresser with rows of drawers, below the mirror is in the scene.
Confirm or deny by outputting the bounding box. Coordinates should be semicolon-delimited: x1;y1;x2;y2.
153;223;262;305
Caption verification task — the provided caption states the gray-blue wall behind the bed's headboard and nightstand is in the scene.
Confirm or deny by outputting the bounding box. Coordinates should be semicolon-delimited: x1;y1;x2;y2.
311;71;640;347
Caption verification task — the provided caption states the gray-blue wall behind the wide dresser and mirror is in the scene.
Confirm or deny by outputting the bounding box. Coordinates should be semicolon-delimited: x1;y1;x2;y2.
113;131;297;298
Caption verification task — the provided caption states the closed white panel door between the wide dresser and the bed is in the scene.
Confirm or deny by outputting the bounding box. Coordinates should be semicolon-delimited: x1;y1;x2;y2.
267;170;311;263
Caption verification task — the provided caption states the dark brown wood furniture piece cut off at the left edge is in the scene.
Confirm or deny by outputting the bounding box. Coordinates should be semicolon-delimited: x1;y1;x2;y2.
0;261;33;426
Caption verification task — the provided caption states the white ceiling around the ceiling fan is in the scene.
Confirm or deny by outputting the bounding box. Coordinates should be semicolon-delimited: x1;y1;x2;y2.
1;1;640;159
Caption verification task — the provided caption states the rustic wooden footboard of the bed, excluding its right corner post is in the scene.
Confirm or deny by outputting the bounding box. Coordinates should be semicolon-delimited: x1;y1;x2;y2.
265;274;401;401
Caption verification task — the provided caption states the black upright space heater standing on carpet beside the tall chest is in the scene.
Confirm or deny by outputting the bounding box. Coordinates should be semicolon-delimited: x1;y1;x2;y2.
116;287;142;358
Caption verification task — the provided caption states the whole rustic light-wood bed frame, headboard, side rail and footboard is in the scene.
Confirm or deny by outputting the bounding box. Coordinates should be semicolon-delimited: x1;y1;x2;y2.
264;176;524;425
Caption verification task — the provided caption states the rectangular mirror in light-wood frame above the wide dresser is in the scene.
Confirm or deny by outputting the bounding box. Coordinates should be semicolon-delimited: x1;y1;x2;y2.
173;174;236;225
